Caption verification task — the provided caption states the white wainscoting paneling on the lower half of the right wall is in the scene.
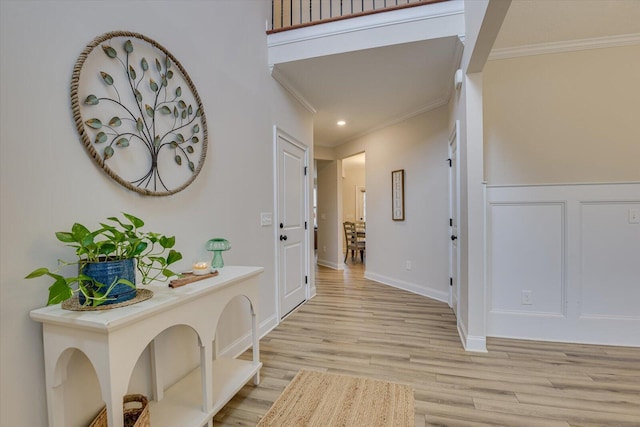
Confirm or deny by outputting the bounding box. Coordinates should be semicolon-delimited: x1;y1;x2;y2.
486;183;640;347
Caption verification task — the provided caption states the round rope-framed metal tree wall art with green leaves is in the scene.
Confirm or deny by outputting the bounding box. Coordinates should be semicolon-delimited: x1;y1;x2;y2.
71;31;207;196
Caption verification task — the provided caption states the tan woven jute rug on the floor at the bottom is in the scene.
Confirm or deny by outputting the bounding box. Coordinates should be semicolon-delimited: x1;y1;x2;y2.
257;371;414;427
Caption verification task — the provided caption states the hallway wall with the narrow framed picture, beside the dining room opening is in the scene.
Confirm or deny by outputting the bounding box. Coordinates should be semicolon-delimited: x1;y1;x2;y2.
336;108;449;301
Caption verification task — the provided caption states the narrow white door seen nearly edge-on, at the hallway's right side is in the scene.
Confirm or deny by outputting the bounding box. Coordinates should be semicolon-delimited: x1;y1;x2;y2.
449;120;460;315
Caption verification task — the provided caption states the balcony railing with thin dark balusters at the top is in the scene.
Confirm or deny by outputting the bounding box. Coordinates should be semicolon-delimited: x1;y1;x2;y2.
267;0;448;34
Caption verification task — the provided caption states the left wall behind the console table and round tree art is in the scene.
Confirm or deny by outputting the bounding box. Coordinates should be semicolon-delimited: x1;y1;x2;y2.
0;0;312;427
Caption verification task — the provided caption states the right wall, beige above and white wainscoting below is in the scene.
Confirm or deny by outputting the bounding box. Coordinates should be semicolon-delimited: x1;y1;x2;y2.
484;45;640;346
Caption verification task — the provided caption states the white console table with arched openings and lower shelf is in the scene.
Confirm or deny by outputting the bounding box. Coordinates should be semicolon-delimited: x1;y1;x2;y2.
31;266;264;427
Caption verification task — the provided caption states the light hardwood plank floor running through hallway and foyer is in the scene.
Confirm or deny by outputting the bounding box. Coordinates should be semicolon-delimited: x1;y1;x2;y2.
215;264;640;427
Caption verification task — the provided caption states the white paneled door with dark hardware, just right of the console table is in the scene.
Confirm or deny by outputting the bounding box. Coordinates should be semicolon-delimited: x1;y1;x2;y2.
276;131;308;318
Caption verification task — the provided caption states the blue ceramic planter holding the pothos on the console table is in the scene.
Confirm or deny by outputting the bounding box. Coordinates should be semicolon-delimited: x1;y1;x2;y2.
78;259;136;305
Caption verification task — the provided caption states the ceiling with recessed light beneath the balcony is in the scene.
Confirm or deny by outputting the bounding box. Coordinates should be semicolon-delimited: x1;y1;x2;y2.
276;37;459;146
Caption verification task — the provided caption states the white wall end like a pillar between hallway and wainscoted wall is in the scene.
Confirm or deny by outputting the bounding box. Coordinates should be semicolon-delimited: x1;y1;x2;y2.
449;0;497;351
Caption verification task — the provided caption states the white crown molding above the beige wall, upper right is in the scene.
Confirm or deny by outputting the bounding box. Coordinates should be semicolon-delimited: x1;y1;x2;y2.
489;33;640;61
